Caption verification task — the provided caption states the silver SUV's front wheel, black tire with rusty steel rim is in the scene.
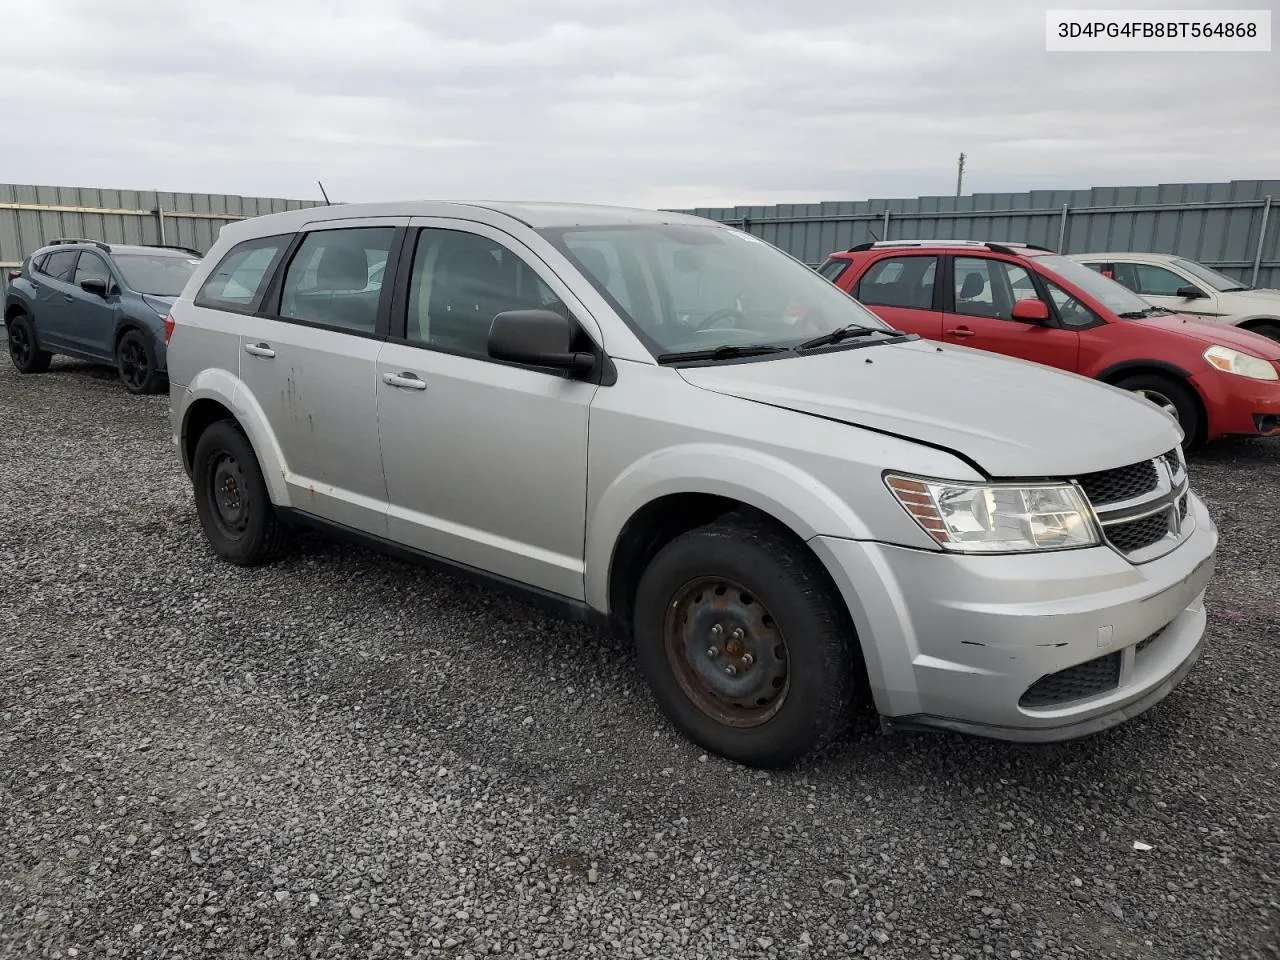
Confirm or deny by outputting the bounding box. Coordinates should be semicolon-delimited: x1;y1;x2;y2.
635;513;863;768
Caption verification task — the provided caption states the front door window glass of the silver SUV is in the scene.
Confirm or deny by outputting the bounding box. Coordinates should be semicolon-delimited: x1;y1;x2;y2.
406;228;571;358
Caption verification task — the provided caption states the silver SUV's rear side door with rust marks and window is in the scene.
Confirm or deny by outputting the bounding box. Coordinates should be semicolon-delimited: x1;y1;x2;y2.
239;218;407;536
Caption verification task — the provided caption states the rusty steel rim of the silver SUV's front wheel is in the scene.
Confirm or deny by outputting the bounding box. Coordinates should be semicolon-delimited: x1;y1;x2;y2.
663;577;790;727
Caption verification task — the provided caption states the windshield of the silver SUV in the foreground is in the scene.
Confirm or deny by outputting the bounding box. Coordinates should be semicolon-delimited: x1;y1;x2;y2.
541;224;890;356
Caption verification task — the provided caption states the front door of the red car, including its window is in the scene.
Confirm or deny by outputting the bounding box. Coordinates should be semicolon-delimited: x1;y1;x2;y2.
942;255;1080;372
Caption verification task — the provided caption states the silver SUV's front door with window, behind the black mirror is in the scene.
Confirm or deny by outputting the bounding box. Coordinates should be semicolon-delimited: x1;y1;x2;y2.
378;219;599;599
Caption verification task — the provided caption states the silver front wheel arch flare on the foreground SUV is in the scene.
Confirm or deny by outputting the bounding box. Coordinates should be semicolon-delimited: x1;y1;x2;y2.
585;443;872;612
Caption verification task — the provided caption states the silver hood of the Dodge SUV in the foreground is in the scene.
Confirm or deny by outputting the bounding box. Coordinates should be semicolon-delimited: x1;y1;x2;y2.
680;340;1181;477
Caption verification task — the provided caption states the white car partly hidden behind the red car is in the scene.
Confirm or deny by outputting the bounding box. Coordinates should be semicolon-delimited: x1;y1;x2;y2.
1071;253;1280;340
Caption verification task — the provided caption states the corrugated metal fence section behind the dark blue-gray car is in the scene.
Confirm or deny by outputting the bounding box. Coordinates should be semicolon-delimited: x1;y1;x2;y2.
0;183;319;292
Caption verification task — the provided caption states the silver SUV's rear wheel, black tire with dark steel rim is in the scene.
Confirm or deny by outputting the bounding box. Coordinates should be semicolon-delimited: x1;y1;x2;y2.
191;420;285;567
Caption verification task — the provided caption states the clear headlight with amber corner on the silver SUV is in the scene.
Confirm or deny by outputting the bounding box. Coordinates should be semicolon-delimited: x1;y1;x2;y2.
884;474;1101;553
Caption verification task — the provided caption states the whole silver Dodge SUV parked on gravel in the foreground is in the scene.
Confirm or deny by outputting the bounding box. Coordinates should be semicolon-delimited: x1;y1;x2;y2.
168;202;1217;765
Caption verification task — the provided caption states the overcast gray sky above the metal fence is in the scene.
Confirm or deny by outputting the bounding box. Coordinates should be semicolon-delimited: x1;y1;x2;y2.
0;0;1280;207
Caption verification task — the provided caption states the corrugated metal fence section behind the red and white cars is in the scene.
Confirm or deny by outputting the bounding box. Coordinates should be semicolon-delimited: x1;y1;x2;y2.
684;180;1280;287
